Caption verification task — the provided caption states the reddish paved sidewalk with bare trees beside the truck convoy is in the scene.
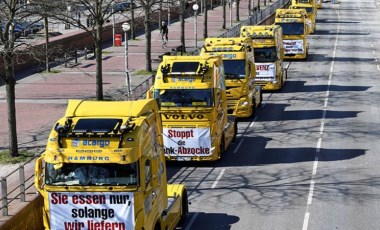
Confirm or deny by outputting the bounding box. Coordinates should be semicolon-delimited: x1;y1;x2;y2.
0;1;282;226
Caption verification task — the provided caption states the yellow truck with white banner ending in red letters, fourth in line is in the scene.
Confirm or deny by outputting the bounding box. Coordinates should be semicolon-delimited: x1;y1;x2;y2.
240;25;287;90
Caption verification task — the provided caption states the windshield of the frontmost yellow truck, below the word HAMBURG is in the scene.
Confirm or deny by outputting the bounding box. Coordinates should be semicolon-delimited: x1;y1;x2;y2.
45;163;138;186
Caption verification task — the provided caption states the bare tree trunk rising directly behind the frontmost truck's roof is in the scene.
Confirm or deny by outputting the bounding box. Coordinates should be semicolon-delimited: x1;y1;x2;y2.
95;24;103;101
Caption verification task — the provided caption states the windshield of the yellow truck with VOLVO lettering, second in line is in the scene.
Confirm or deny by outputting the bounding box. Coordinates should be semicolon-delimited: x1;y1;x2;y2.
155;89;214;107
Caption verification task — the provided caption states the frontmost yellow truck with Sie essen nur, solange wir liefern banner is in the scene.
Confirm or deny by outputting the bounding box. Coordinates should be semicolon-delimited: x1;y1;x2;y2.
35;99;188;230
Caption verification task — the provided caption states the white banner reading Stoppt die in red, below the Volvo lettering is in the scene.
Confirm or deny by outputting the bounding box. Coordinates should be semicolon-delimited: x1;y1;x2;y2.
163;128;211;157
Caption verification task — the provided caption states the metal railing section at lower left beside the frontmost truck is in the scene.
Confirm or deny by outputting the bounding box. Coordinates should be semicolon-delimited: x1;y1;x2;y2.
0;152;42;216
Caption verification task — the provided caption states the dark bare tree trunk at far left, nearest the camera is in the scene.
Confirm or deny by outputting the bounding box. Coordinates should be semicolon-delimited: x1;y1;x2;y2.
3;52;19;157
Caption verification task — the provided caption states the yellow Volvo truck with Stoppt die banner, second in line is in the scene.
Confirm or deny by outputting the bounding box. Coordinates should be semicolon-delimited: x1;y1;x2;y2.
147;55;237;161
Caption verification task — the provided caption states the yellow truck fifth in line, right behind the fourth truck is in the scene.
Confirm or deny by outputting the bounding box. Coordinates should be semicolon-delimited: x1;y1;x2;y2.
275;9;310;60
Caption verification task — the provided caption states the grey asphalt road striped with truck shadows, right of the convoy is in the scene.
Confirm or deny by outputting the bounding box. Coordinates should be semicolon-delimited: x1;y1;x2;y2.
168;0;380;230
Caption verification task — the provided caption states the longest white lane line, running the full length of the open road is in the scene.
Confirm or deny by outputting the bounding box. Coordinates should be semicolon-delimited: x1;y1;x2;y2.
302;3;340;230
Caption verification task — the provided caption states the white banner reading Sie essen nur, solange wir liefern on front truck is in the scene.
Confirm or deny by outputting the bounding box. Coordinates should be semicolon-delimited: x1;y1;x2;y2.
49;192;135;230
